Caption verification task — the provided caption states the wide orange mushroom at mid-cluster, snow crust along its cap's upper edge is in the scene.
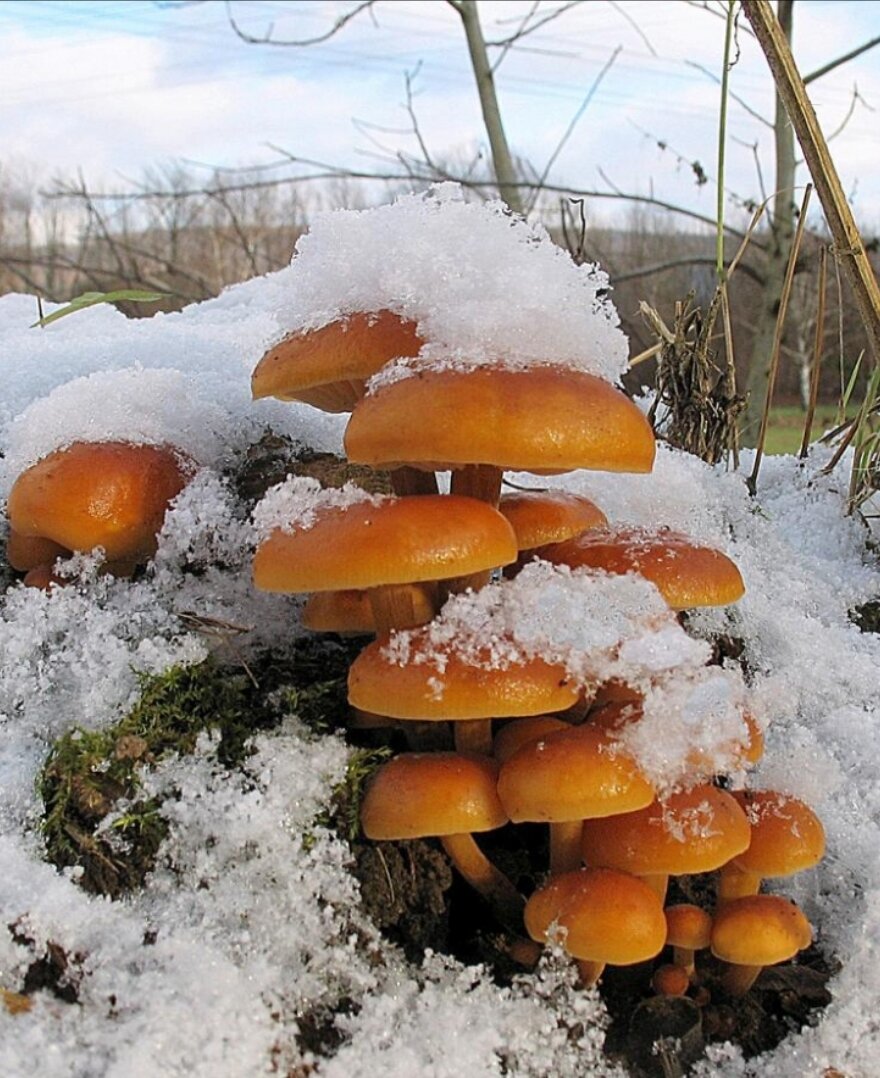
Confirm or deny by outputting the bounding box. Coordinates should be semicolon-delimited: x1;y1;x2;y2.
348;620;578;754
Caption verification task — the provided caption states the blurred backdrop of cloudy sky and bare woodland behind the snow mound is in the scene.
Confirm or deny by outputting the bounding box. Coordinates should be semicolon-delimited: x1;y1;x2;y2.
0;0;880;441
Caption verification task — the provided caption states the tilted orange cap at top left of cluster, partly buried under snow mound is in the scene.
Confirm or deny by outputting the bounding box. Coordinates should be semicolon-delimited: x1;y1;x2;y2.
251;310;423;412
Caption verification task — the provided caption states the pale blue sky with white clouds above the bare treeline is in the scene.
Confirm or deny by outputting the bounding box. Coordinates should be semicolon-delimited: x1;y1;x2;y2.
0;0;880;224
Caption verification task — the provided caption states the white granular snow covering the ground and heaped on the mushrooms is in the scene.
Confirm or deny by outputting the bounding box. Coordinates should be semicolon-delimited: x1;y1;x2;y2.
0;183;880;1078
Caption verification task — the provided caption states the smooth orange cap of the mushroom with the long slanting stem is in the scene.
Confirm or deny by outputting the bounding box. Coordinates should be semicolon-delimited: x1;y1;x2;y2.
360;752;507;840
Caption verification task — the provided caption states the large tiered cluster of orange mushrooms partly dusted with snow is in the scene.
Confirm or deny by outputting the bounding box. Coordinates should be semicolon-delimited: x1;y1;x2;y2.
245;200;822;994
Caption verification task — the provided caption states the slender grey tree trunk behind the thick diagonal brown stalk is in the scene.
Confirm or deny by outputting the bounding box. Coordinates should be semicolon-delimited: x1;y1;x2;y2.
742;0;795;445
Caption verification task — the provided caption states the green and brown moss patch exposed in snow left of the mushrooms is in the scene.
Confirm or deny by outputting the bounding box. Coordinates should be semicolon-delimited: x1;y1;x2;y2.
38;640;358;897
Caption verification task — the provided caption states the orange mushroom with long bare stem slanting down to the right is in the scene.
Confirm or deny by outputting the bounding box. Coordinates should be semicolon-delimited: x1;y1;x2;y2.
360;752;523;931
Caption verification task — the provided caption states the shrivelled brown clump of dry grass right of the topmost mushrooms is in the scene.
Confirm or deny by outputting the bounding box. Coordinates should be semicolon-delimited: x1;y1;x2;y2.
640;288;745;465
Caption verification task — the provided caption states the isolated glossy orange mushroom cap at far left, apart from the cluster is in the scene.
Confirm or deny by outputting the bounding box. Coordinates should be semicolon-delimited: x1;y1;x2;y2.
6;442;192;568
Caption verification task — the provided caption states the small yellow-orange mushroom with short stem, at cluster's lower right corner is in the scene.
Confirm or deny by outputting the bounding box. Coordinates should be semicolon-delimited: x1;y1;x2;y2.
712;895;813;996
